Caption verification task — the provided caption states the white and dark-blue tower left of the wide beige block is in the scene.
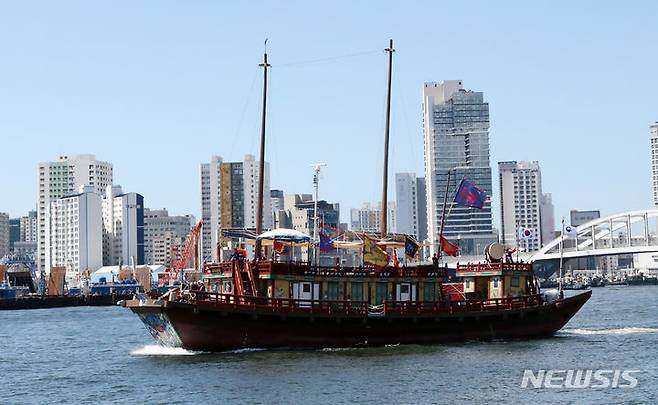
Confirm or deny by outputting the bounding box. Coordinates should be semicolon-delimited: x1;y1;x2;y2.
103;185;144;266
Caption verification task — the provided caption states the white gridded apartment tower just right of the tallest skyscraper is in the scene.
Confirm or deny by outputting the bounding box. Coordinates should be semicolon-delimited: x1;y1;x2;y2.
498;161;540;252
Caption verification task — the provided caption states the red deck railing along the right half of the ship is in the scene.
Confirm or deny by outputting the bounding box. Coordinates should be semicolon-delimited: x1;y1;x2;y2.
384;294;542;315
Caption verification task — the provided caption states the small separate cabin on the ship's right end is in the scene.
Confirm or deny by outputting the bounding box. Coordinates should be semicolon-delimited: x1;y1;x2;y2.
456;261;539;300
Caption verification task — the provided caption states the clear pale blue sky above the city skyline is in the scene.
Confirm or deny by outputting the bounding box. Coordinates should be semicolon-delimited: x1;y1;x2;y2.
0;1;658;229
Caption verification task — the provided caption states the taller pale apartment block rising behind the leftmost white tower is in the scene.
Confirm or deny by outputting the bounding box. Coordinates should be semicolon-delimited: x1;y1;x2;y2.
36;154;112;272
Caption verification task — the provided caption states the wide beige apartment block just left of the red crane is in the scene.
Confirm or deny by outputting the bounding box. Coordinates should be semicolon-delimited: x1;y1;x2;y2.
144;208;196;266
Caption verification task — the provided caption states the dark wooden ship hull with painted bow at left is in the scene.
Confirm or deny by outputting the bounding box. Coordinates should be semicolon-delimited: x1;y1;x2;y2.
123;291;591;352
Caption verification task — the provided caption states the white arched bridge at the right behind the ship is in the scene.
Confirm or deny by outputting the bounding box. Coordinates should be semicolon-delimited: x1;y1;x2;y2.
530;208;658;274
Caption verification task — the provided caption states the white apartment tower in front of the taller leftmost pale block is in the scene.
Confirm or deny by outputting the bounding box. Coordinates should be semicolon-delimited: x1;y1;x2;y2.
46;186;103;282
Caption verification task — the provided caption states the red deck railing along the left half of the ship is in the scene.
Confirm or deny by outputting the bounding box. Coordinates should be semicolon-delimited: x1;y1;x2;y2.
193;291;368;315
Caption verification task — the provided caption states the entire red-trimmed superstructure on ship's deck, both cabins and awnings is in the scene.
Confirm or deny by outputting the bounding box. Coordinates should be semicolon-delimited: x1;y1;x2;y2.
195;229;539;312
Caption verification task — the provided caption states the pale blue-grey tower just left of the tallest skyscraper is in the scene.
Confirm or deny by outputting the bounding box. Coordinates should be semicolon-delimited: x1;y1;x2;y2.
395;173;427;241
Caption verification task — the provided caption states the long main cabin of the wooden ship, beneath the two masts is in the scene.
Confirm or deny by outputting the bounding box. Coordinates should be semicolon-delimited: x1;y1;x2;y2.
203;260;443;307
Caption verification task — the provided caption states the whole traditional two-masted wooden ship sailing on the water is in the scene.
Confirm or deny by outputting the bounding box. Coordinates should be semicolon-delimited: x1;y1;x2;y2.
122;41;591;351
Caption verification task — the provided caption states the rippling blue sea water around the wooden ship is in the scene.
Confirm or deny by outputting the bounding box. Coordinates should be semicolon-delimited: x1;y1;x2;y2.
0;286;658;404
